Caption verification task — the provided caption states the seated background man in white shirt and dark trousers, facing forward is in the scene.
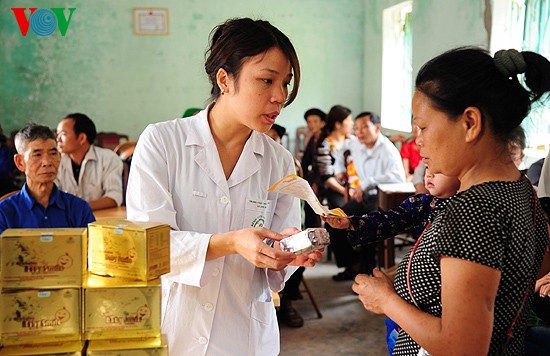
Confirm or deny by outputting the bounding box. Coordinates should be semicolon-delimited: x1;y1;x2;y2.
330;112;406;281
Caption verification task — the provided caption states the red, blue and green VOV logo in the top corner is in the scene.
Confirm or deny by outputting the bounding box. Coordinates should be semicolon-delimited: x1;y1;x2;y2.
11;7;76;36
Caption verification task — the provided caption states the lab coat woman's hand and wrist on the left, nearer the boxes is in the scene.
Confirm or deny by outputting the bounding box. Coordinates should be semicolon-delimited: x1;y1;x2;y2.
211;227;299;270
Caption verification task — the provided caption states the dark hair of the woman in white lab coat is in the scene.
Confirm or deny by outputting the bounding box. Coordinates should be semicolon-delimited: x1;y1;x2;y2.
204;18;300;106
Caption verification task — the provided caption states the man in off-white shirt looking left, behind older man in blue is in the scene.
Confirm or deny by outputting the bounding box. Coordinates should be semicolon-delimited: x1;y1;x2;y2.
56;113;122;210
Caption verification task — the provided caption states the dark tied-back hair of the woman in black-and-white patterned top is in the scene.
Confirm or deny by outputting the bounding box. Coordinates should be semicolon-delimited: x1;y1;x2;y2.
416;47;550;142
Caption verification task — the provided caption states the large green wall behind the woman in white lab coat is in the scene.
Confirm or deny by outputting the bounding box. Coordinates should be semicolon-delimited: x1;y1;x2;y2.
0;0;364;147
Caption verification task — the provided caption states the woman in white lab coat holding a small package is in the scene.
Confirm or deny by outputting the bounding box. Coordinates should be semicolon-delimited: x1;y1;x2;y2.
127;18;321;355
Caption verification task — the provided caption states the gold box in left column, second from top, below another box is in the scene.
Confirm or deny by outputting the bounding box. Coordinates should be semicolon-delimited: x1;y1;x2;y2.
0;288;81;345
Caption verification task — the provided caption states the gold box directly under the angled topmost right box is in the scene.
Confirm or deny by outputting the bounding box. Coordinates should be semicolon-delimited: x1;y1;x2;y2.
83;275;161;340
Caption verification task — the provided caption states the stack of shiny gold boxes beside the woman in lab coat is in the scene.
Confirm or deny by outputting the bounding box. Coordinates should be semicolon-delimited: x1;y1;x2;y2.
0;219;170;356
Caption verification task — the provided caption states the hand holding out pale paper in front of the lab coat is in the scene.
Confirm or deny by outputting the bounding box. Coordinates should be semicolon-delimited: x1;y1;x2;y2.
268;174;348;218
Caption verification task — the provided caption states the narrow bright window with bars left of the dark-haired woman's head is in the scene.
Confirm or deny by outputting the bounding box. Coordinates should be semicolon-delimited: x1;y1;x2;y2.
381;1;413;132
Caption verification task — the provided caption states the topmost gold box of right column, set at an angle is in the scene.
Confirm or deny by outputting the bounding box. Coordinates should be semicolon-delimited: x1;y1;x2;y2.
88;218;170;281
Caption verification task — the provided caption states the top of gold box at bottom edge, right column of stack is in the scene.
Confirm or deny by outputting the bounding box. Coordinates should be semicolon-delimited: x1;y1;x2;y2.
86;335;168;356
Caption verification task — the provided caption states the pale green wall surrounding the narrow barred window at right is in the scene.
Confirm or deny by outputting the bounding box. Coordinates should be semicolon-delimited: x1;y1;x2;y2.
363;0;489;133
